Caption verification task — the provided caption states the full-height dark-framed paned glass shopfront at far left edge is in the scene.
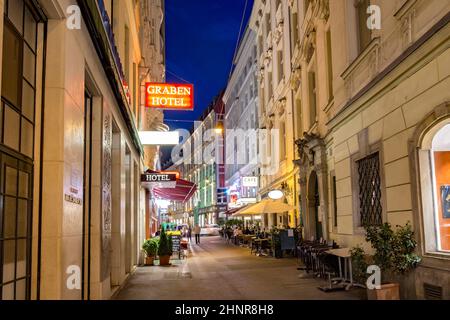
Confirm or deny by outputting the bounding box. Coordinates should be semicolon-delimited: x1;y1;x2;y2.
0;0;38;300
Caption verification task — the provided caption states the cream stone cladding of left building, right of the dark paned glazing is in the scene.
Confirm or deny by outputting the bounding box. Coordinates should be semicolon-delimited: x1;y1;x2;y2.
41;1;142;299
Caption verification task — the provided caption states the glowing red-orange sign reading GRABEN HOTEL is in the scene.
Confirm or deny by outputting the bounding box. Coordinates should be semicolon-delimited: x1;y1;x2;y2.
145;83;194;111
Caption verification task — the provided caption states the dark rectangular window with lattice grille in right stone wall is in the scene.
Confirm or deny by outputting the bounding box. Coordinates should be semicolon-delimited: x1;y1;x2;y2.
357;152;383;227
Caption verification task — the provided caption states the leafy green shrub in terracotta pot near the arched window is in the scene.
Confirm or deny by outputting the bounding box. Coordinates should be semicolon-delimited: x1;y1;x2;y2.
352;223;421;300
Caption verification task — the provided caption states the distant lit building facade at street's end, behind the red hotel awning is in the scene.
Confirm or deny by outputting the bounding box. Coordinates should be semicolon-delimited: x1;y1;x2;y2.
167;92;227;227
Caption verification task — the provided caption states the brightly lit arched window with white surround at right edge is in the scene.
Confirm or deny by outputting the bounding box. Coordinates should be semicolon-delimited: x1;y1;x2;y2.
419;119;450;253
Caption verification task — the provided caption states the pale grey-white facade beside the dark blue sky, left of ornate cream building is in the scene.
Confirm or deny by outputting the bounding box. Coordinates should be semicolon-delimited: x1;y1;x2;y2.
223;28;259;210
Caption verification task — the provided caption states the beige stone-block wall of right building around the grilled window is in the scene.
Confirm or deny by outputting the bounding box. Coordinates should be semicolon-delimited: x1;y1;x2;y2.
329;1;450;250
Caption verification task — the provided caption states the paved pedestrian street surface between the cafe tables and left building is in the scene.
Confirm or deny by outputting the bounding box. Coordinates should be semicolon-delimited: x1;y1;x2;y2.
115;237;364;300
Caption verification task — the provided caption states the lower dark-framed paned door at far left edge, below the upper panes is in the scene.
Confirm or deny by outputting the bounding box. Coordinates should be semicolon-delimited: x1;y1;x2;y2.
0;152;33;300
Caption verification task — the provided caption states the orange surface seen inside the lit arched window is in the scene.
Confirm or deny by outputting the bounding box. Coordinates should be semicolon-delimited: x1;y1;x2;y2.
434;151;450;251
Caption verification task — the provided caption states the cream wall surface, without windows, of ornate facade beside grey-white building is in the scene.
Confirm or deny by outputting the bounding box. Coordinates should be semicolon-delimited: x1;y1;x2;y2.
250;0;295;226
